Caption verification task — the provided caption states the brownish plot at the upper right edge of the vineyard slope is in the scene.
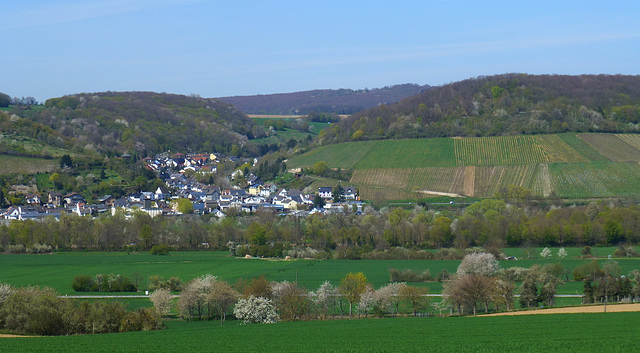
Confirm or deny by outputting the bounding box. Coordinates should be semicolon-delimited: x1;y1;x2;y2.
578;134;640;162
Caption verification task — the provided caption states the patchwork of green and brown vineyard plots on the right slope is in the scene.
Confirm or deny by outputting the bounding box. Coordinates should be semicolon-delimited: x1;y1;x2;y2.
287;133;640;200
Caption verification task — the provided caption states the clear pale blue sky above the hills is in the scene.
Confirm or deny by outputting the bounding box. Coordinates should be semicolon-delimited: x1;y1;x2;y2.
0;0;640;102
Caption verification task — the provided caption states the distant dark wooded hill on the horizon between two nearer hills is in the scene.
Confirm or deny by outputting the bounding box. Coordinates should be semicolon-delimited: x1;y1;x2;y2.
219;84;431;115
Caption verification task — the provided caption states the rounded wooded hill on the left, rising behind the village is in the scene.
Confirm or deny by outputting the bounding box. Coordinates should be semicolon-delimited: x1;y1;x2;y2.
5;92;252;155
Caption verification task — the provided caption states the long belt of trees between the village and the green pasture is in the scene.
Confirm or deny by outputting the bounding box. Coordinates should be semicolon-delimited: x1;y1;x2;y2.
0;200;640;253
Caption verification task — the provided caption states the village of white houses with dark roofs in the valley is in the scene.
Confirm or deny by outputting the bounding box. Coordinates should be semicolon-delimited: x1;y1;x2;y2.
0;153;363;220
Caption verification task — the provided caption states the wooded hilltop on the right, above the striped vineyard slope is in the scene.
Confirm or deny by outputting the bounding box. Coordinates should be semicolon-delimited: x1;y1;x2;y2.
321;74;640;143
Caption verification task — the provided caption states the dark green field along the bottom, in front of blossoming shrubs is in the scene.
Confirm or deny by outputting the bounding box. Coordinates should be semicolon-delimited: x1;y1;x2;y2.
0;313;640;353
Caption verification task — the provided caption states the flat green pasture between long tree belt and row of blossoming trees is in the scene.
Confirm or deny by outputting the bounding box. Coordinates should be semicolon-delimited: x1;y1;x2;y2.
0;248;640;295
